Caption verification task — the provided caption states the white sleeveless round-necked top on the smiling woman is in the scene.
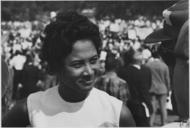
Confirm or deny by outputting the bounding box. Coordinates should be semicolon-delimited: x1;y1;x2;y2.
26;86;122;127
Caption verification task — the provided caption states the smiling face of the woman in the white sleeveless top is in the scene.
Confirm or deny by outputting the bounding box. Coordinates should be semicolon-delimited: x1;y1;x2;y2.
61;40;99;93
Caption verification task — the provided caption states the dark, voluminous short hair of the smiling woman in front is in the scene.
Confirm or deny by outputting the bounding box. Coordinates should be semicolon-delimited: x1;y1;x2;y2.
42;11;101;74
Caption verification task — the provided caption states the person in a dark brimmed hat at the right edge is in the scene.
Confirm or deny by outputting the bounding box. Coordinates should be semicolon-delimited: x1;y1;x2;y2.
145;0;189;122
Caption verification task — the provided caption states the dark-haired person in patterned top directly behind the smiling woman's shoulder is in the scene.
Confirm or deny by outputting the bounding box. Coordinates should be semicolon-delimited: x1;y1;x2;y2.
95;52;130;103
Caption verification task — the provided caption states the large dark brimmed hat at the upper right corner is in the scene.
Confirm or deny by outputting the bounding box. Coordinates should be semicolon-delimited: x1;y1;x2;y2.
144;0;189;43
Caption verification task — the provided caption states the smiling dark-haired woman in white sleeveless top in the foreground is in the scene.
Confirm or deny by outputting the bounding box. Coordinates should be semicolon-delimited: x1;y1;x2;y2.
2;12;135;127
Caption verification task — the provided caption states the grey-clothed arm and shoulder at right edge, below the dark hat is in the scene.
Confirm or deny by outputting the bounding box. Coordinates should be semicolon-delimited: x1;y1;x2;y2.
173;20;189;121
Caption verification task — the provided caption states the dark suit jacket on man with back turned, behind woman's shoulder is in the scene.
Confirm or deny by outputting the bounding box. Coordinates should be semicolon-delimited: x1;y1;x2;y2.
118;65;152;112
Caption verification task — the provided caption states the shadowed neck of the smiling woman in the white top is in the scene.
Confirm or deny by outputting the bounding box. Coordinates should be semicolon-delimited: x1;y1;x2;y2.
58;85;89;103
